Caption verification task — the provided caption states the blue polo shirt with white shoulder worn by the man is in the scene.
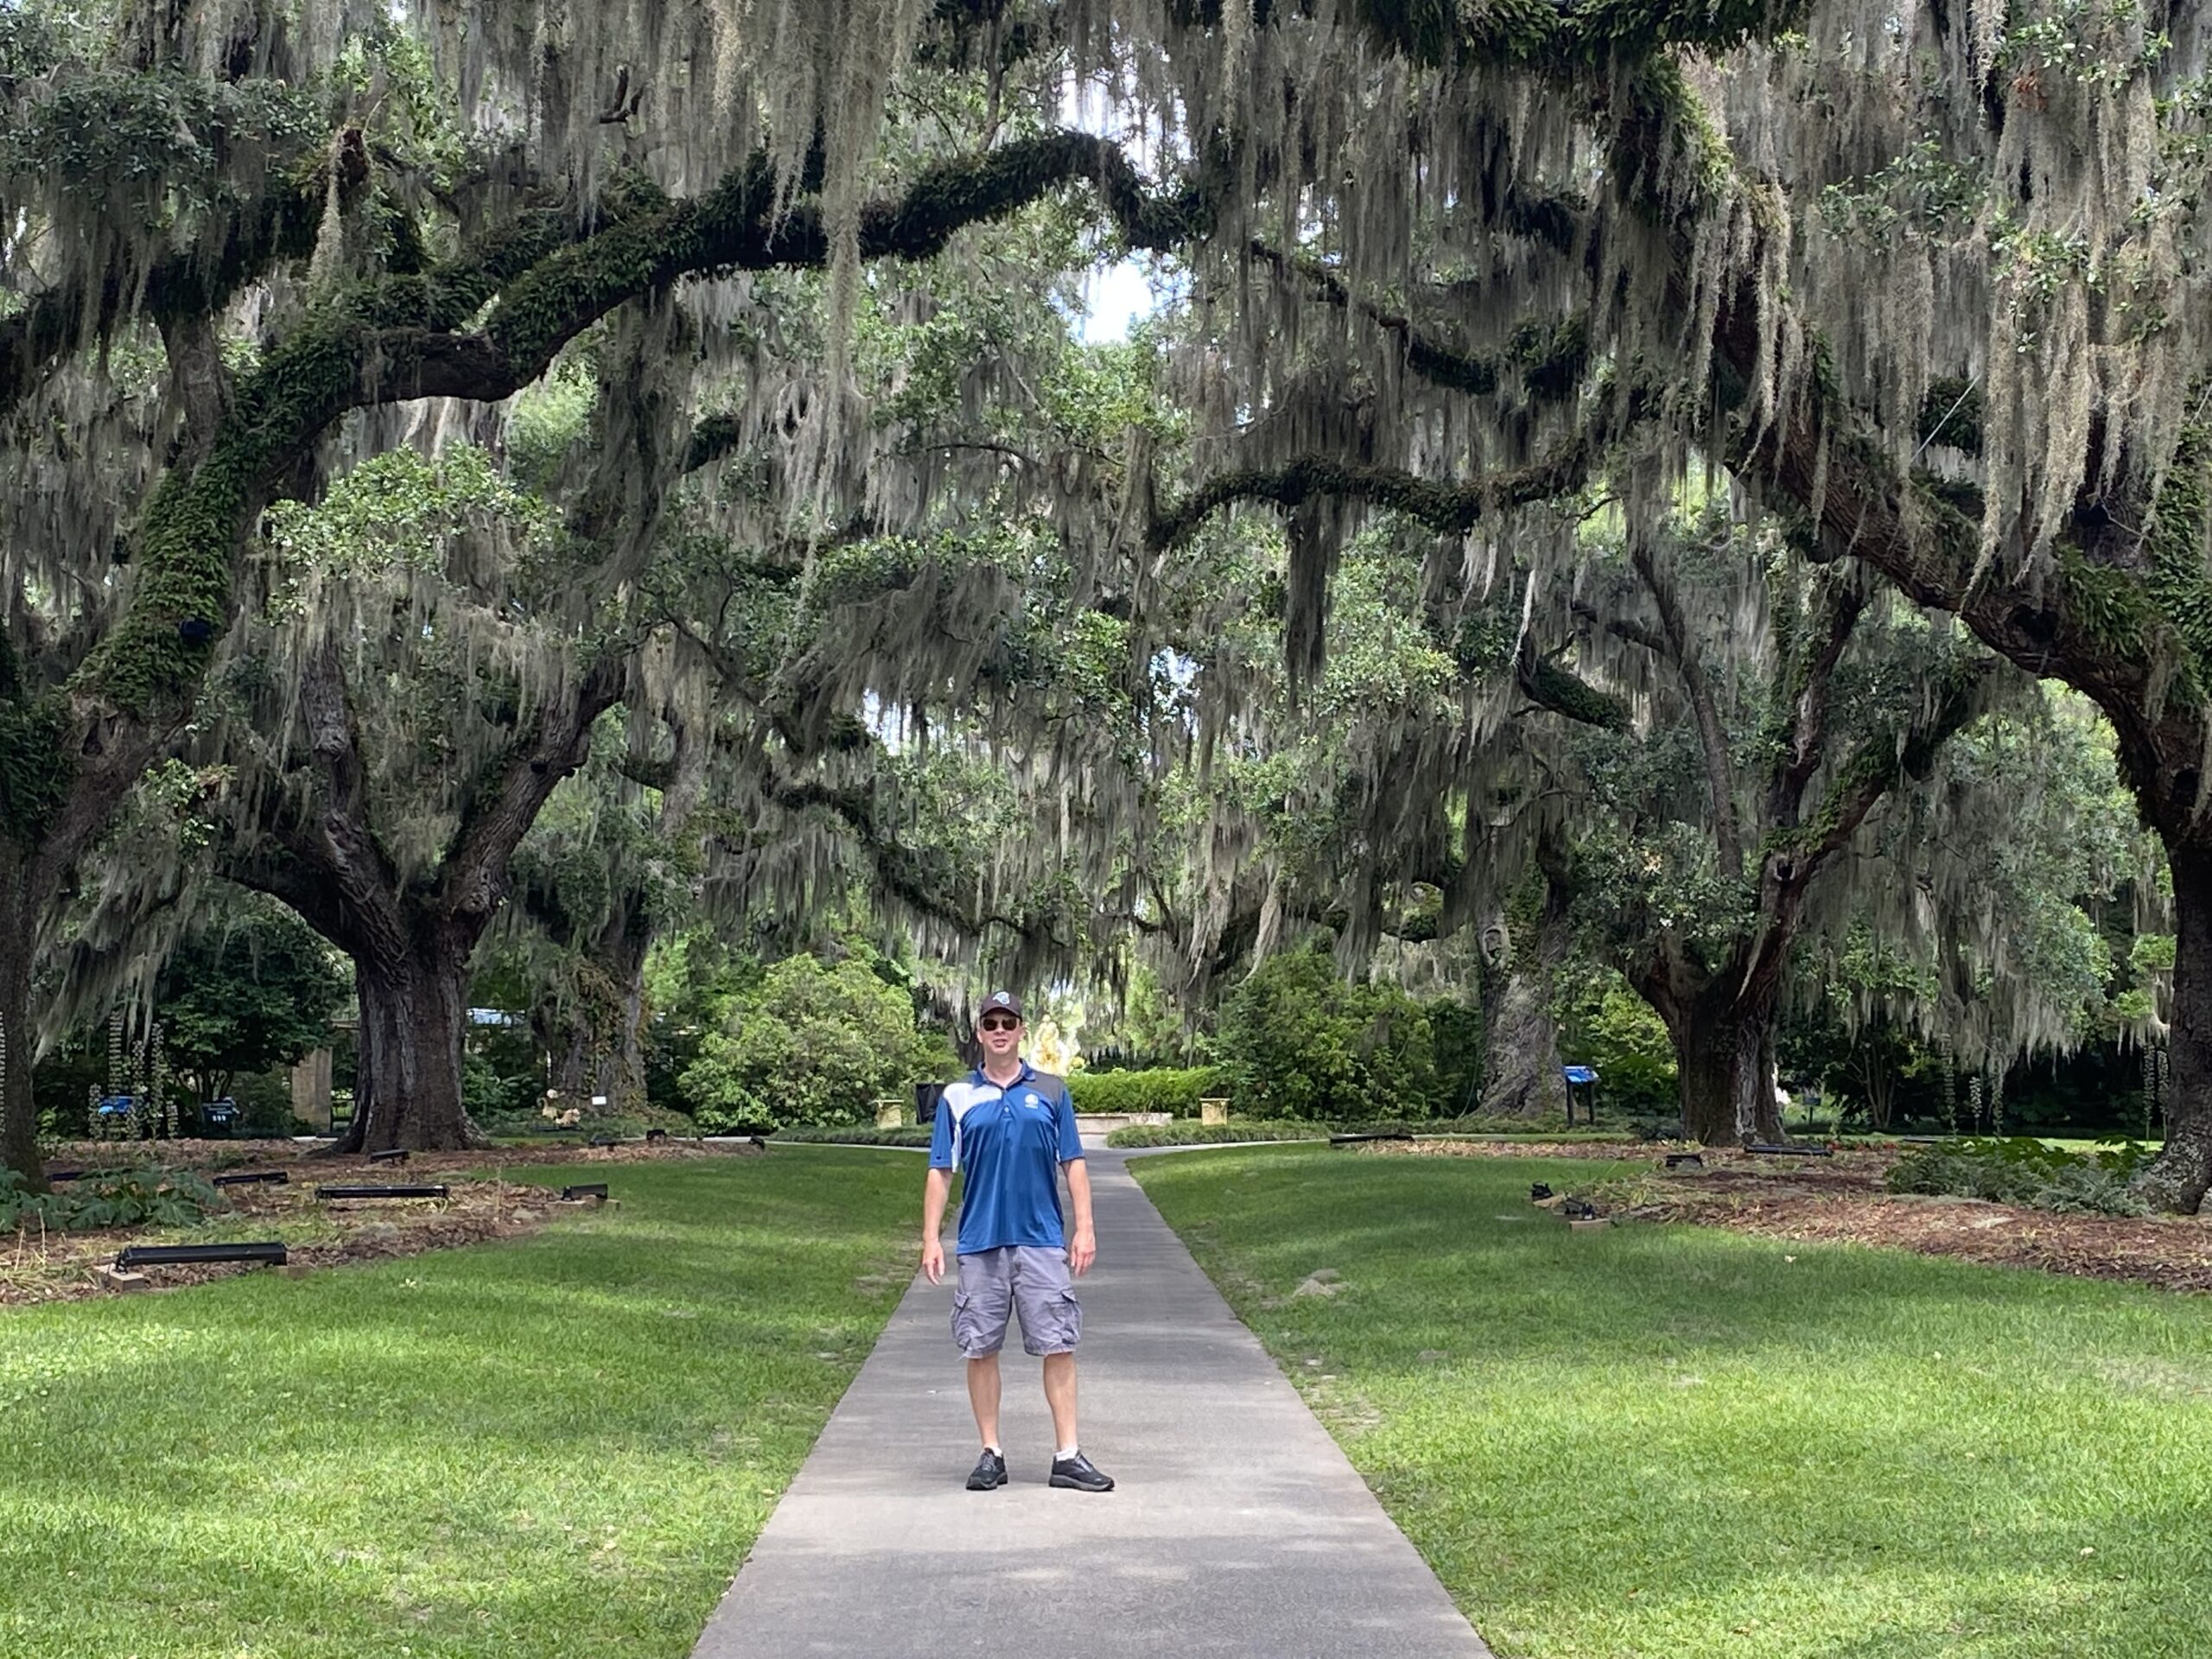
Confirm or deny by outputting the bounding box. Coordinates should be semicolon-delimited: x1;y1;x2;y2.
929;1064;1084;1256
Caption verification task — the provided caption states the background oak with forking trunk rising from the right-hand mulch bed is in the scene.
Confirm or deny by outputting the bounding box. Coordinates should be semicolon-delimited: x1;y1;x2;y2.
1568;515;2018;1144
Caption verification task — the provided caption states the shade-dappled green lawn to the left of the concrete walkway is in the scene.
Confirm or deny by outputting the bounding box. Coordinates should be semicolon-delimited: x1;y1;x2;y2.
0;1148;920;1659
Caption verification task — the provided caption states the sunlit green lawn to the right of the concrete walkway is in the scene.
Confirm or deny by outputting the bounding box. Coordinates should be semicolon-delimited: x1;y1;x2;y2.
1130;1148;2212;1659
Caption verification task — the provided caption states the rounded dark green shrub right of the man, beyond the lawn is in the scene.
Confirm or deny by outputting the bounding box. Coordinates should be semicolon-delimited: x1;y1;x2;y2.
1219;951;1438;1119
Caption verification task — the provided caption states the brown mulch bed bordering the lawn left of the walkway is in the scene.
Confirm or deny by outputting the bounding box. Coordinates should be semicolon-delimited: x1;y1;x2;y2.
0;1139;759;1305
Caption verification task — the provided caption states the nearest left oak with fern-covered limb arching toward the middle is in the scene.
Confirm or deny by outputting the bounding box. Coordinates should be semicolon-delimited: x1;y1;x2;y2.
0;7;1188;1174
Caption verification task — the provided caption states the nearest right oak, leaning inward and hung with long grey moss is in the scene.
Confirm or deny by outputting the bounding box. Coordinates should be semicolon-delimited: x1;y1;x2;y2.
1021;0;2212;1208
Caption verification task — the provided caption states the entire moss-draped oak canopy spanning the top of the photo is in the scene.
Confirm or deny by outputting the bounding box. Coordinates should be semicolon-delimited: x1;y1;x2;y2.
0;0;2212;1208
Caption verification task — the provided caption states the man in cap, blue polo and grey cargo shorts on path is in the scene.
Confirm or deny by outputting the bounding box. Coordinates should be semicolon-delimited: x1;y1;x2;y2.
923;991;1113;1491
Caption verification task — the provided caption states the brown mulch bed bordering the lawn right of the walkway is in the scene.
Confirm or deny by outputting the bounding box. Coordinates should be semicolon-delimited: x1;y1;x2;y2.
1371;1141;2212;1289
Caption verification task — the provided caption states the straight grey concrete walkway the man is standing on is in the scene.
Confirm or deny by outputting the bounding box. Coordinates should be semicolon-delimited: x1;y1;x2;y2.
695;1148;1489;1659
